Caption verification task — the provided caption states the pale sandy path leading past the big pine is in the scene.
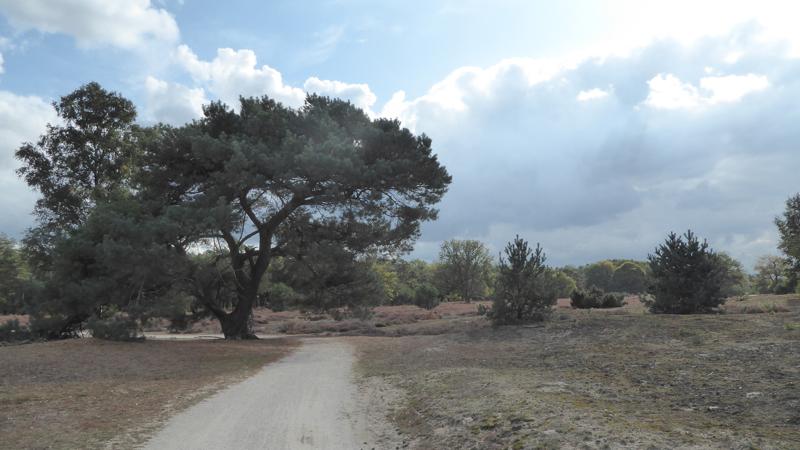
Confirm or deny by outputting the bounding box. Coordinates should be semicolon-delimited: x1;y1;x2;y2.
145;338;382;450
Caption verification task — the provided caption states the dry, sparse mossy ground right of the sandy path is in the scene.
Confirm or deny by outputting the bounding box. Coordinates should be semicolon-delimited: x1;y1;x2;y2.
350;296;800;449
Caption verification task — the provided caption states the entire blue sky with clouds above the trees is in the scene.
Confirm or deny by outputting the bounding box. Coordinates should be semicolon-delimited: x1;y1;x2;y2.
0;0;800;269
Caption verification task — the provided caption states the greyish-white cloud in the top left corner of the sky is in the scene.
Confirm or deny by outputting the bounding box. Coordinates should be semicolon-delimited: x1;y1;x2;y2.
0;0;179;49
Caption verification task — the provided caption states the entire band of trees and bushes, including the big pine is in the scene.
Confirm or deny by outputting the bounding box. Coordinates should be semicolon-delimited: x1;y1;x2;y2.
0;83;800;339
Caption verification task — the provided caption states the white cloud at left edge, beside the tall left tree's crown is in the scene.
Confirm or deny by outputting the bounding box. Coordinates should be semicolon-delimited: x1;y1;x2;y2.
0;91;56;237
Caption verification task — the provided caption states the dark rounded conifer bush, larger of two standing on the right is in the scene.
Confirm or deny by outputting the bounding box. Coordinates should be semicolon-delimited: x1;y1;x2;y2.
647;230;725;314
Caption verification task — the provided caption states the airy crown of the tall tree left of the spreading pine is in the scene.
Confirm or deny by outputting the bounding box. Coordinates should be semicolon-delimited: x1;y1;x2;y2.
16;83;136;271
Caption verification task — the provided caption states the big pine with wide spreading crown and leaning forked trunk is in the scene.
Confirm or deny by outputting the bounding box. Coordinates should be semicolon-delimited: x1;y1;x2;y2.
142;96;450;338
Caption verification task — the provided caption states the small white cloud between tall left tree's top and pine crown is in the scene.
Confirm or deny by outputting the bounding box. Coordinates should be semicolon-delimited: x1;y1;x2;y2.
145;77;208;125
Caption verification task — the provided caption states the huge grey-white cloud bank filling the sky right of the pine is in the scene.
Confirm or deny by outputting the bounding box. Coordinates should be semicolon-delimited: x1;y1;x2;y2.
382;36;800;265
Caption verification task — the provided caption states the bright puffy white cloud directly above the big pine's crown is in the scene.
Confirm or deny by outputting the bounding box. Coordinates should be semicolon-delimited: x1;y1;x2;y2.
175;45;305;108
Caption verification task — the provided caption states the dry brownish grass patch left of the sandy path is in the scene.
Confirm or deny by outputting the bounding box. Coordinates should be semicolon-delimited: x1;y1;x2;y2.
0;339;295;449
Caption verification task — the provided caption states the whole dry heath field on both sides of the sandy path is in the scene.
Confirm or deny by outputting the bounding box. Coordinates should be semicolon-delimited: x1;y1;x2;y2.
0;295;800;449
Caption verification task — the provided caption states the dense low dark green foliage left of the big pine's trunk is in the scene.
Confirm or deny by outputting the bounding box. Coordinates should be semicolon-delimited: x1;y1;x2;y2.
23;195;191;337
